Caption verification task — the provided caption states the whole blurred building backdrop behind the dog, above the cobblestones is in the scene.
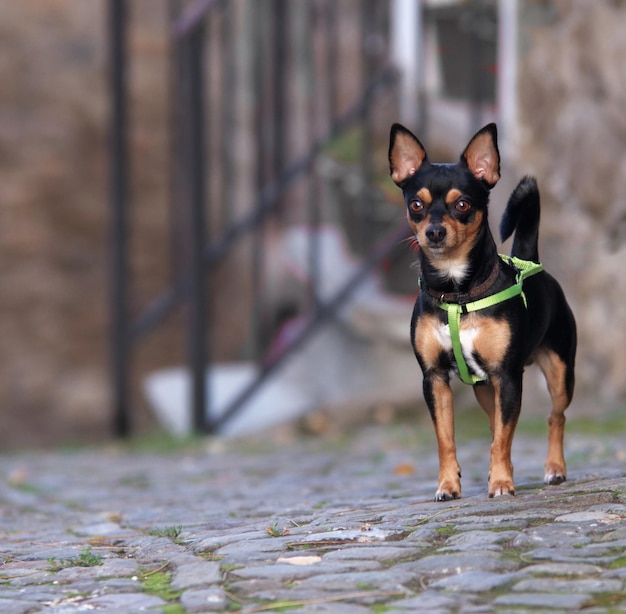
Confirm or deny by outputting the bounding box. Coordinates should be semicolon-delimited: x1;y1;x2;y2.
0;0;626;448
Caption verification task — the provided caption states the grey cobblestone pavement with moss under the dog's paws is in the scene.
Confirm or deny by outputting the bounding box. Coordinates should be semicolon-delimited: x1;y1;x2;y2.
0;424;626;614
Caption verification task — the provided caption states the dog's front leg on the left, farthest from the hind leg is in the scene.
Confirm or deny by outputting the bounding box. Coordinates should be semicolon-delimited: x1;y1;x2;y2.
424;373;461;501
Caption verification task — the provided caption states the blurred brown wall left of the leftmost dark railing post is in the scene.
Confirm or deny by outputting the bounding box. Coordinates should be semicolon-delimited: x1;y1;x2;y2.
0;0;106;446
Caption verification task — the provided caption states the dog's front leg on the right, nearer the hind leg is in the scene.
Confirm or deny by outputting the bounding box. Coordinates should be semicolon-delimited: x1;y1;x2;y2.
489;376;522;497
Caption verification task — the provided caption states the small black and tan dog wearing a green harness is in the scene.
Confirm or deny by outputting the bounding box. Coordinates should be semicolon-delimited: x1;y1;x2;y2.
389;124;576;501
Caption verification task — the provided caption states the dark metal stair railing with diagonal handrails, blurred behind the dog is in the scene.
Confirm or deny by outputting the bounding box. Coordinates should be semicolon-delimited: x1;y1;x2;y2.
109;0;406;435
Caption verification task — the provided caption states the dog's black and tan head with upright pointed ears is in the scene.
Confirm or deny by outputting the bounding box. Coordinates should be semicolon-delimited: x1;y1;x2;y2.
389;124;500;278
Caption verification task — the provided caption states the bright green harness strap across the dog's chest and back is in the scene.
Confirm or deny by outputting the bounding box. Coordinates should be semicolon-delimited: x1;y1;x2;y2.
439;254;543;385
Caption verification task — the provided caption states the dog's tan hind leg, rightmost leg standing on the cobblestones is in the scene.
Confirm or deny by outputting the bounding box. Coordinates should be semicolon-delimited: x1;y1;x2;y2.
535;349;572;484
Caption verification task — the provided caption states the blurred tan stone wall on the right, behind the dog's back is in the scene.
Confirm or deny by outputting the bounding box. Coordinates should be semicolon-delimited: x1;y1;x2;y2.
518;0;626;411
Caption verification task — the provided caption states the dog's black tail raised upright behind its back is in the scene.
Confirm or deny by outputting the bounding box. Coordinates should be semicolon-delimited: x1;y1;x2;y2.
500;175;540;262
